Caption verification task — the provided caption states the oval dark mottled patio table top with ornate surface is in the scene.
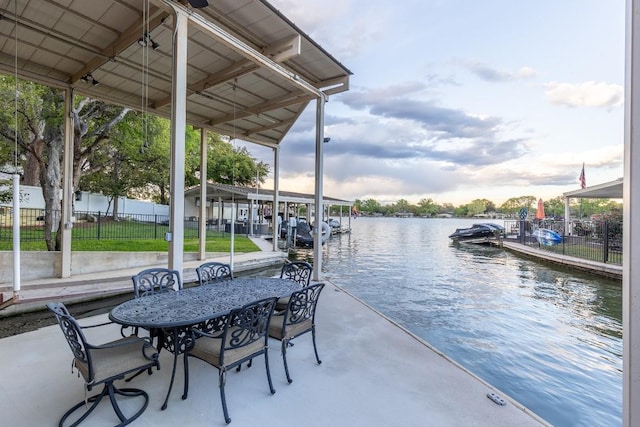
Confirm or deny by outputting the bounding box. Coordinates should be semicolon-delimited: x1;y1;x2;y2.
109;277;300;328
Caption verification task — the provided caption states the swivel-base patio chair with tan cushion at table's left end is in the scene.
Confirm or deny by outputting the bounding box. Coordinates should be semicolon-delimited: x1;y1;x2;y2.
47;303;160;426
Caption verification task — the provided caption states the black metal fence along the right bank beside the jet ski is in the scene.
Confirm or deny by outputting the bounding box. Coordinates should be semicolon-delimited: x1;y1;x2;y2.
505;220;622;265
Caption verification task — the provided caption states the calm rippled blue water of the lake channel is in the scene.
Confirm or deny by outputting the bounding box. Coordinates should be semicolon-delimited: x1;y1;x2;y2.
294;218;622;426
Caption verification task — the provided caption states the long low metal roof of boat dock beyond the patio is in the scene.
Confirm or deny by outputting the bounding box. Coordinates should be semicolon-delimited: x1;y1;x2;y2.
184;183;353;206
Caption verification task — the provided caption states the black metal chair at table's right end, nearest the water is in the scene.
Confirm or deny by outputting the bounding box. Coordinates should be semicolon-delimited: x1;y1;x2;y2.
269;283;324;383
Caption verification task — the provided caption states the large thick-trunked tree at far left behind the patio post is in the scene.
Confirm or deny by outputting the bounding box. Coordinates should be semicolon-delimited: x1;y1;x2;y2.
0;76;128;250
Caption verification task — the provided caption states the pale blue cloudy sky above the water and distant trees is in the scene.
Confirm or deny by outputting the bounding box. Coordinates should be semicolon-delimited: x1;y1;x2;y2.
239;0;625;206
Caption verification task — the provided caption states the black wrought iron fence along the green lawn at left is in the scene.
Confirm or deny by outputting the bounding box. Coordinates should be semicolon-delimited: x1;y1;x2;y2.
0;207;231;242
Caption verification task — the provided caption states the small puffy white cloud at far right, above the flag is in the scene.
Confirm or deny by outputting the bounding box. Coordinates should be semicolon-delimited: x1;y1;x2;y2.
544;81;624;108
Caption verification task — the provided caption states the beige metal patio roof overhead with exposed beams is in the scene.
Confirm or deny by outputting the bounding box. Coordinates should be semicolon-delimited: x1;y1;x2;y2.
0;0;351;147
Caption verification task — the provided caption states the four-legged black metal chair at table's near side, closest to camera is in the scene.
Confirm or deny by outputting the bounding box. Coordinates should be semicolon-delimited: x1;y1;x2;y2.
183;297;276;424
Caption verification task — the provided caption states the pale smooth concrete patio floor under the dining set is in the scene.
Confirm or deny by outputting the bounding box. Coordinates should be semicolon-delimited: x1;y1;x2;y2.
0;283;547;427
